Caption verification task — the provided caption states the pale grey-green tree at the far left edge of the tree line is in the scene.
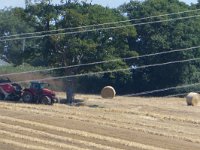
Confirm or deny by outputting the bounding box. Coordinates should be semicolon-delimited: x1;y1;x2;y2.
0;8;33;65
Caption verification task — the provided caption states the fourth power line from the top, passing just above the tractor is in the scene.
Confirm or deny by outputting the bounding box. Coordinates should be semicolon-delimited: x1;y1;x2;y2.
0;57;200;86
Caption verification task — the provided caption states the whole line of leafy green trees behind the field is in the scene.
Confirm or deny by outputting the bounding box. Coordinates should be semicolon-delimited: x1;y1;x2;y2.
0;0;200;95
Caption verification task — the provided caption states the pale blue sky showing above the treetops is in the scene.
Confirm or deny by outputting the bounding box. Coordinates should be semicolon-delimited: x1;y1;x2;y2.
0;0;197;9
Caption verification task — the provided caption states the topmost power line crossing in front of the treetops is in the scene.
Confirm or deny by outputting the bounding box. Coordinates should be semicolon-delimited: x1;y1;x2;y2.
0;9;200;39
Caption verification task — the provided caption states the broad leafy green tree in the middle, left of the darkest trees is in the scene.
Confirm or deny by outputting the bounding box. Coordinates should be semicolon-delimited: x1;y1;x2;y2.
54;3;137;91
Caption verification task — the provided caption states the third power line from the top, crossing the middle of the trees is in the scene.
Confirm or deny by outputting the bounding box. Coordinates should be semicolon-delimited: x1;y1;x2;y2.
0;45;200;77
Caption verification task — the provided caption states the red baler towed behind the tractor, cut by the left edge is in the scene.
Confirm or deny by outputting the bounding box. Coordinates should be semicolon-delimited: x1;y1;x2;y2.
0;77;22;101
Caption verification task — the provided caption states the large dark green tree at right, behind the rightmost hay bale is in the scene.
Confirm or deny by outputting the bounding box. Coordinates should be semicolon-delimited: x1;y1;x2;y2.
120;0;200;94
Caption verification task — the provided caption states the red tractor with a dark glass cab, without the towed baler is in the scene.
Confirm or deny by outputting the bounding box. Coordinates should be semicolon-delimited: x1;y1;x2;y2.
22;81;57;105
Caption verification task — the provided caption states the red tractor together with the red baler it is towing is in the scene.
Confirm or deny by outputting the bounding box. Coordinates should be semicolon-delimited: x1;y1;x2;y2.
0;78;58;105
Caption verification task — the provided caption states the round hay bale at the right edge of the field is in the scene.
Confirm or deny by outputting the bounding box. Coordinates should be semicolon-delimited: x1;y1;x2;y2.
186;92;200;106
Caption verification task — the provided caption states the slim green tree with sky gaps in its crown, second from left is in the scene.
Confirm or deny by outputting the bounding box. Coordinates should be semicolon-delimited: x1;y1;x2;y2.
24;0;58;66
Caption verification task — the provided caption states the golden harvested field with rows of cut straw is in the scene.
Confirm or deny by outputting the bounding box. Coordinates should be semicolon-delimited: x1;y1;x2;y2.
0;93;200;150
